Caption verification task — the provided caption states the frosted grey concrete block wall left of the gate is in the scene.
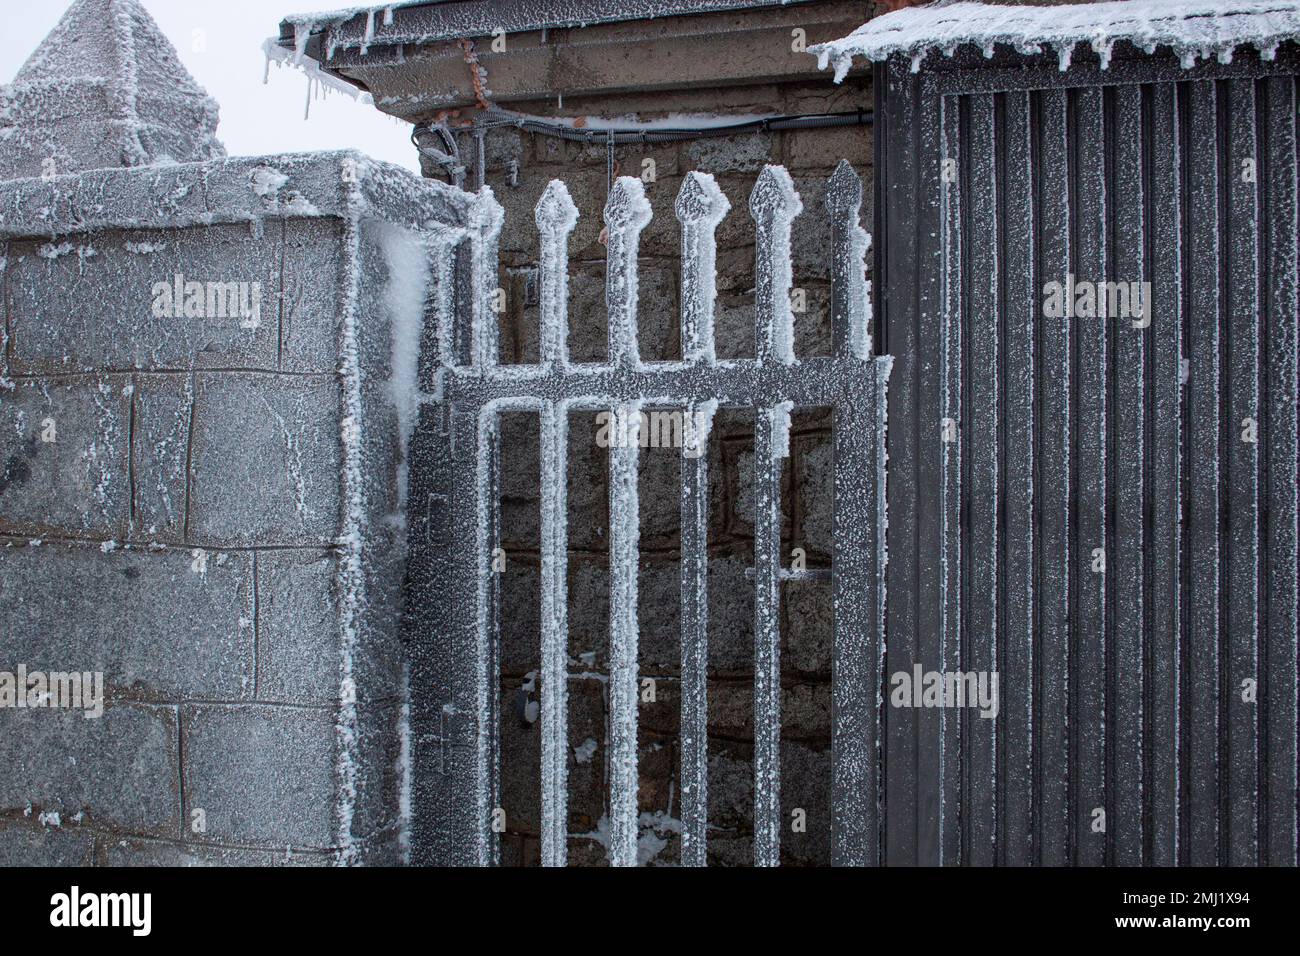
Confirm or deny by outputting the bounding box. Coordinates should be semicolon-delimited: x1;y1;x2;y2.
0;155;468;865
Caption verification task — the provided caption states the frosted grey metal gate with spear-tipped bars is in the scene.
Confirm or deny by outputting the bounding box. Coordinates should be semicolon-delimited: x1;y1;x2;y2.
410;163;891;866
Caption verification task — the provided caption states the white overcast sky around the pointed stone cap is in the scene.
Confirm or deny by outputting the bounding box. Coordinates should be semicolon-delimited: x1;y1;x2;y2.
0;0;419;169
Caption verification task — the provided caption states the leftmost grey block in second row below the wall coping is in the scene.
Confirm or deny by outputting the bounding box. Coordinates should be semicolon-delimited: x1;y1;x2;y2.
0;377;131;537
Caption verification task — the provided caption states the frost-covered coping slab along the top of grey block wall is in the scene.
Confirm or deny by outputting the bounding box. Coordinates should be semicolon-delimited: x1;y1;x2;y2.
0;152;477;239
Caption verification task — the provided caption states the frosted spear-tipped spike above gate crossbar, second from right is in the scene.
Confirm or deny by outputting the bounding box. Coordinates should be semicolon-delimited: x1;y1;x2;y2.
749;166;803;365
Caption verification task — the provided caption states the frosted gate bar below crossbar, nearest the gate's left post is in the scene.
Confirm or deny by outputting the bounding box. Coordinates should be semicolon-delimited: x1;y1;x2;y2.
541;405;568;866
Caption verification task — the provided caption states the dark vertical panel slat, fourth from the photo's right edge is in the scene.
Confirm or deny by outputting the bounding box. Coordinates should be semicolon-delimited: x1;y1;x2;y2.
1143;83;1183;866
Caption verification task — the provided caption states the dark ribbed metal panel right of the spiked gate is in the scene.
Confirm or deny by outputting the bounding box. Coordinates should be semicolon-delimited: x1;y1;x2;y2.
876;49;1297;865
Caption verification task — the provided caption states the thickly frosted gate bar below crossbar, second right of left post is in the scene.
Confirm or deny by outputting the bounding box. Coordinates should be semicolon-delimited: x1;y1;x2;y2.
610;403;641;866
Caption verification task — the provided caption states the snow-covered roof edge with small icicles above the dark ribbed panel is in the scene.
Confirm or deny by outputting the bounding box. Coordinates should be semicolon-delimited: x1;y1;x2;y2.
809;0;1300;82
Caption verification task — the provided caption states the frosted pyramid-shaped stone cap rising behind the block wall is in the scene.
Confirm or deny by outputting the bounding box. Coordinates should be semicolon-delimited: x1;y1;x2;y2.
0;0;225;179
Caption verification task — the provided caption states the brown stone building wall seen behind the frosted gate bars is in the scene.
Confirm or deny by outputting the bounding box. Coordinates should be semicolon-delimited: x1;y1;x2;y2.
426;77;872;865
